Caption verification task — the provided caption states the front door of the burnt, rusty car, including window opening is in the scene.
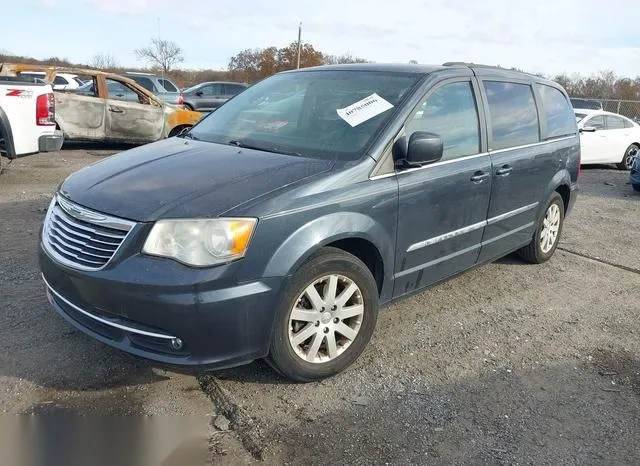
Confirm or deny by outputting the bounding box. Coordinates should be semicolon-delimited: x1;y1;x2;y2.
106;79;164;142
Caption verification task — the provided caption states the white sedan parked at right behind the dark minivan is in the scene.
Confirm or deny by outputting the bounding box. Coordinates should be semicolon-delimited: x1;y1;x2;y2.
574;109;640;170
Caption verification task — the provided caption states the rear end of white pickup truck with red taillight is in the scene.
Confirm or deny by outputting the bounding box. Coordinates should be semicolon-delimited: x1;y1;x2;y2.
0;76;63;170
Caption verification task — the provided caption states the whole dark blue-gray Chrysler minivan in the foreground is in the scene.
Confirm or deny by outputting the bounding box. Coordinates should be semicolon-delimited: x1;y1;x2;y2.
40;63;580;381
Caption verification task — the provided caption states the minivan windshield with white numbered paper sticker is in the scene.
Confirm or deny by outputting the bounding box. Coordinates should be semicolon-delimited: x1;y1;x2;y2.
189;70;421;160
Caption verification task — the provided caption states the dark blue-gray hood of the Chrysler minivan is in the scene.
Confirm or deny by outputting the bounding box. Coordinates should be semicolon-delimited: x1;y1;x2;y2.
60;138;333;222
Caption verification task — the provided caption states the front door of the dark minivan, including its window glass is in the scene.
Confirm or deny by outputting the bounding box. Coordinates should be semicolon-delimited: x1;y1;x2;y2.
394;78;491;296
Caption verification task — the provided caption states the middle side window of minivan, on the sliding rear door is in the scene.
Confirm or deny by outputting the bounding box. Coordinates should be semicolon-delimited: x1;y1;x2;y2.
484;81;540;150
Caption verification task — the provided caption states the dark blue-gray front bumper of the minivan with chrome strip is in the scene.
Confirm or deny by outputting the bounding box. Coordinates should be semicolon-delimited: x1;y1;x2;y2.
39;245;282;369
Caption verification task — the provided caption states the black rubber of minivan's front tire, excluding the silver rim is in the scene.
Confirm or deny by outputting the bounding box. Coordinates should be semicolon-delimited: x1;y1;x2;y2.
269;248;378;382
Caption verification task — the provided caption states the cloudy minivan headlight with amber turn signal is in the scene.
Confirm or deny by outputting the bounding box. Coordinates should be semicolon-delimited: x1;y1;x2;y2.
142;218;257;267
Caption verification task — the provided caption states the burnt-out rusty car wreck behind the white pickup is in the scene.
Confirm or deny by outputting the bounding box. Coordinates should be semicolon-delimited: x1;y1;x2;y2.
2;64;201;143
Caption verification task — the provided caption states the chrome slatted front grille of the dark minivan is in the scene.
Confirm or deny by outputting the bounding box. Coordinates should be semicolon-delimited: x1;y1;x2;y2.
42;195;135;270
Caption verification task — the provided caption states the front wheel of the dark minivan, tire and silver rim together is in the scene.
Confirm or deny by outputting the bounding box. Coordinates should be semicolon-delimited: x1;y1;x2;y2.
267;248;378;382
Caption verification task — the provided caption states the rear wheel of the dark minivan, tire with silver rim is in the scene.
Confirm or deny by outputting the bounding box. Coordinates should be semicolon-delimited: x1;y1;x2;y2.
517;192;564;264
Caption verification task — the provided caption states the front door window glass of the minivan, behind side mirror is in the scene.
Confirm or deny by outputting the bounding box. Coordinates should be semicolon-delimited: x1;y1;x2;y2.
406;82;480;160
